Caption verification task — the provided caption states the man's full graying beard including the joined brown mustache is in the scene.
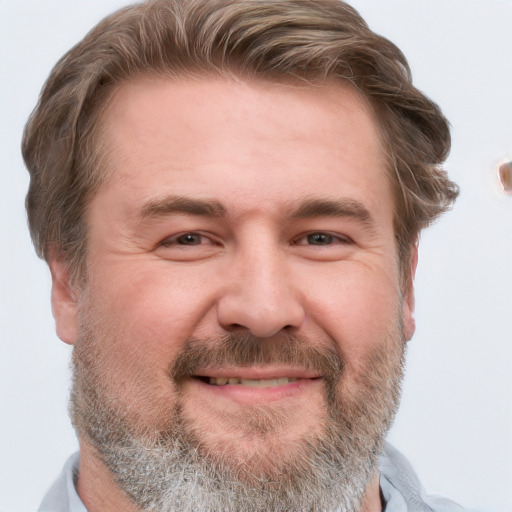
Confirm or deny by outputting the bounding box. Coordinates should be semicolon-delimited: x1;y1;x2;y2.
70;329;405;512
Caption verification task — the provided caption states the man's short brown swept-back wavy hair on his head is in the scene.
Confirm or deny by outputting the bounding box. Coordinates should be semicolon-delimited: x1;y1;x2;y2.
23;0;458;279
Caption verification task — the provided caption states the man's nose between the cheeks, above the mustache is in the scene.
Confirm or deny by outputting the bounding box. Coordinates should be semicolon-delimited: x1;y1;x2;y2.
217;248;305;338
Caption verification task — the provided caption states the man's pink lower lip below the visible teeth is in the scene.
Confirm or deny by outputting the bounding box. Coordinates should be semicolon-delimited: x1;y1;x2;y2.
190;378;323;405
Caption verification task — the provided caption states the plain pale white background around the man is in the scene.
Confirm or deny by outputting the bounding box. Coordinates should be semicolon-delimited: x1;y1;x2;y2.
0;0;512;512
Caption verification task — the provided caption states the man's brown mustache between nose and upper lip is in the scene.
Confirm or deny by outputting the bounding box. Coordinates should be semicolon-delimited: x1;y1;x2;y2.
168;333;344;384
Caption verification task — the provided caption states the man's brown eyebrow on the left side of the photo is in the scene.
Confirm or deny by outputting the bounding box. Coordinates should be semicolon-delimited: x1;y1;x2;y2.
140;196;227;219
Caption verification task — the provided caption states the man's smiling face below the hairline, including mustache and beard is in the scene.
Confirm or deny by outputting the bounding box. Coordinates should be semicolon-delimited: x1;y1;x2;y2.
52;78;413;510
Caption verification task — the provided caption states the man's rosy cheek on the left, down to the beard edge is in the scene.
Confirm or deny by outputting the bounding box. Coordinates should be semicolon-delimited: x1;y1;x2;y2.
75;267;210;429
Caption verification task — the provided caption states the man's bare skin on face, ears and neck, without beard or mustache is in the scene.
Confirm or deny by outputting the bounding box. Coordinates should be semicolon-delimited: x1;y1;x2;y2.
51;78;416;512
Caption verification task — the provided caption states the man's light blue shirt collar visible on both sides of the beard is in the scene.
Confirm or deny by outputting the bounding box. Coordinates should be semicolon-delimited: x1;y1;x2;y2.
38;443;463;512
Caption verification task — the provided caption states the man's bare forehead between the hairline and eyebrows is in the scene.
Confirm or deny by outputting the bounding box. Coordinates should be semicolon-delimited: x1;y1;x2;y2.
95;77;390;218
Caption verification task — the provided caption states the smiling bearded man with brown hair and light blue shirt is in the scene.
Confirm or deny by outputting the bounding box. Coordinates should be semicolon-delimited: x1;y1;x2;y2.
23;0;459;512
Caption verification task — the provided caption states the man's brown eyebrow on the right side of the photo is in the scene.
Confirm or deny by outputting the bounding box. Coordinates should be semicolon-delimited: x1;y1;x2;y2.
290;198;375;227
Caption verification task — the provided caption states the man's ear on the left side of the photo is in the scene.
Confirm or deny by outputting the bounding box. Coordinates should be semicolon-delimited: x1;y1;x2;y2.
49;257;78;345
